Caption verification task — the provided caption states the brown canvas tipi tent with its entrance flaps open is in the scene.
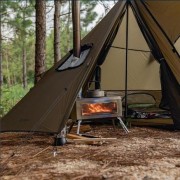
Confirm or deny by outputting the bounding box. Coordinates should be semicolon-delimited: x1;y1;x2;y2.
0;0;180;133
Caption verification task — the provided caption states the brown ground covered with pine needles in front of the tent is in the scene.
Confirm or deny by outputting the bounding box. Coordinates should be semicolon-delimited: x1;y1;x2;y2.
0;125;180;180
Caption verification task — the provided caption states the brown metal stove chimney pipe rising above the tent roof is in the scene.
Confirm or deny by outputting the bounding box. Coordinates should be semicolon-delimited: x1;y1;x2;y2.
72;0;81;58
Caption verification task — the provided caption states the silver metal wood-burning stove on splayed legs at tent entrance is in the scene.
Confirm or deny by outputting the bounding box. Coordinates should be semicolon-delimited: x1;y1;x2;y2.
76;96;129;134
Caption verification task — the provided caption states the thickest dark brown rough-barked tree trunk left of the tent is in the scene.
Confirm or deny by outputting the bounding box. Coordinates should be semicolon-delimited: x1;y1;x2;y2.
34;0;46;84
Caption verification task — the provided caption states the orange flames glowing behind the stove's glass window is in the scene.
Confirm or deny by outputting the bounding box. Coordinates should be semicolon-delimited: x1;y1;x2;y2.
82;102;117;116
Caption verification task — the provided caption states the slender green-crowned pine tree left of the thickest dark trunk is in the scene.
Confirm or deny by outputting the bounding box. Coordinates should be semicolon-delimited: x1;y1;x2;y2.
8;0;34;89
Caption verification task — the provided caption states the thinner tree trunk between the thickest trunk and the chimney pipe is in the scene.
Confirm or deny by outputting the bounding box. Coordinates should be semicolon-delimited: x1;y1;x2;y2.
54;0;61;64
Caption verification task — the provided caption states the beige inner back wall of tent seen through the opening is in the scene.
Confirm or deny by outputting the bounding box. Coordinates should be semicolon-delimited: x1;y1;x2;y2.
101;8;161;90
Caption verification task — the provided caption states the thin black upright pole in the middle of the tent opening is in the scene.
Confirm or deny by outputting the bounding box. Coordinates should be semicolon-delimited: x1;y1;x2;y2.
124;0;129;120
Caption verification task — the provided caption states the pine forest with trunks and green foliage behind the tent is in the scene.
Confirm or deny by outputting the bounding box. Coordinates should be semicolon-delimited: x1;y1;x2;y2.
0;0;117;117
